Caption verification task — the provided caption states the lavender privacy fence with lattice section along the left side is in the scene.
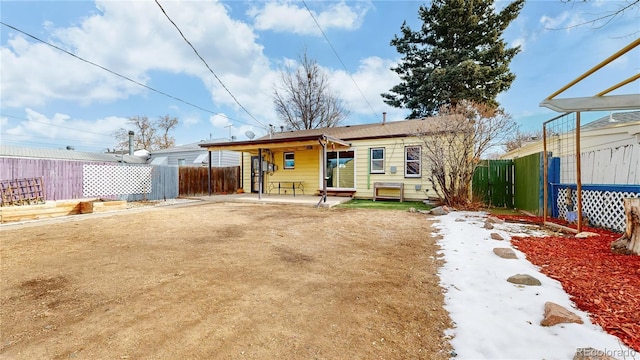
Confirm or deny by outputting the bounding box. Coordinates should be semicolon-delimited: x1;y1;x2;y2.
0;158;178;201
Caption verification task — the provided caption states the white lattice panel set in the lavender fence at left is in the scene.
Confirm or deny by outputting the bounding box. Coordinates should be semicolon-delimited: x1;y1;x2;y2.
82;165;153;197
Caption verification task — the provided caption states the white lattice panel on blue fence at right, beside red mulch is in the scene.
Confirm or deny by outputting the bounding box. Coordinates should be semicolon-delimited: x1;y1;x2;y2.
556;189;640;232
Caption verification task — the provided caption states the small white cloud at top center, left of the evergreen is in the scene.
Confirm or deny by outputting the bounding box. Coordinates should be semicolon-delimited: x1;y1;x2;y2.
247;1;370;36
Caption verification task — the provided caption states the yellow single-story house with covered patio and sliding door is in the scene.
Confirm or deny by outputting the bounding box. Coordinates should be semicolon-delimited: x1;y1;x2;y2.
199;118;436;200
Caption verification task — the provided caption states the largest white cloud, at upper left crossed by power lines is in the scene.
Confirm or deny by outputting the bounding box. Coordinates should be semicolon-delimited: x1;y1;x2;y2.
0;1;268;112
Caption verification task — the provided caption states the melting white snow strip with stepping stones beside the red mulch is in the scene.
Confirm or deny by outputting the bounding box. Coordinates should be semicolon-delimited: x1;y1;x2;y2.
434;212;640;360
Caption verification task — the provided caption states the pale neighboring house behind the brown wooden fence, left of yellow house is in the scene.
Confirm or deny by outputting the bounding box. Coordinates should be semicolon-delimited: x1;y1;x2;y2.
149;139;240;167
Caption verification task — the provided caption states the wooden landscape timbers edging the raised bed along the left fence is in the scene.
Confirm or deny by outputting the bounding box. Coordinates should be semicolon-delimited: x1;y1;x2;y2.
0;199;127;223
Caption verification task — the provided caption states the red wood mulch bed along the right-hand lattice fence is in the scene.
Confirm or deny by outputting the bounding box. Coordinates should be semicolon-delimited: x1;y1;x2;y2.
499;215;640;351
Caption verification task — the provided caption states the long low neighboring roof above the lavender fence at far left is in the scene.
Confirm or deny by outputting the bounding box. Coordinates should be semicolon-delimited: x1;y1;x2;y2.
0;145;146;164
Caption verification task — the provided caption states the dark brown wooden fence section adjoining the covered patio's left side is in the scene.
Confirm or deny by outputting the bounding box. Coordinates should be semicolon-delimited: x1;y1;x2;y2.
178;166;240;196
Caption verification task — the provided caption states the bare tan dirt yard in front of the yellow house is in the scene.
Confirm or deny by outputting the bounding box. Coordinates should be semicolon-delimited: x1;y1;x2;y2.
0;203;451;359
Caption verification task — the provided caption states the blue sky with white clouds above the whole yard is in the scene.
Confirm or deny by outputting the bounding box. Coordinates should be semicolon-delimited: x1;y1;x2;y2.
0;0;640;152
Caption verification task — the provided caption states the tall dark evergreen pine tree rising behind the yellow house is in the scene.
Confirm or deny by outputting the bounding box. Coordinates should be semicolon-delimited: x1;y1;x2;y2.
382;0;525;118
